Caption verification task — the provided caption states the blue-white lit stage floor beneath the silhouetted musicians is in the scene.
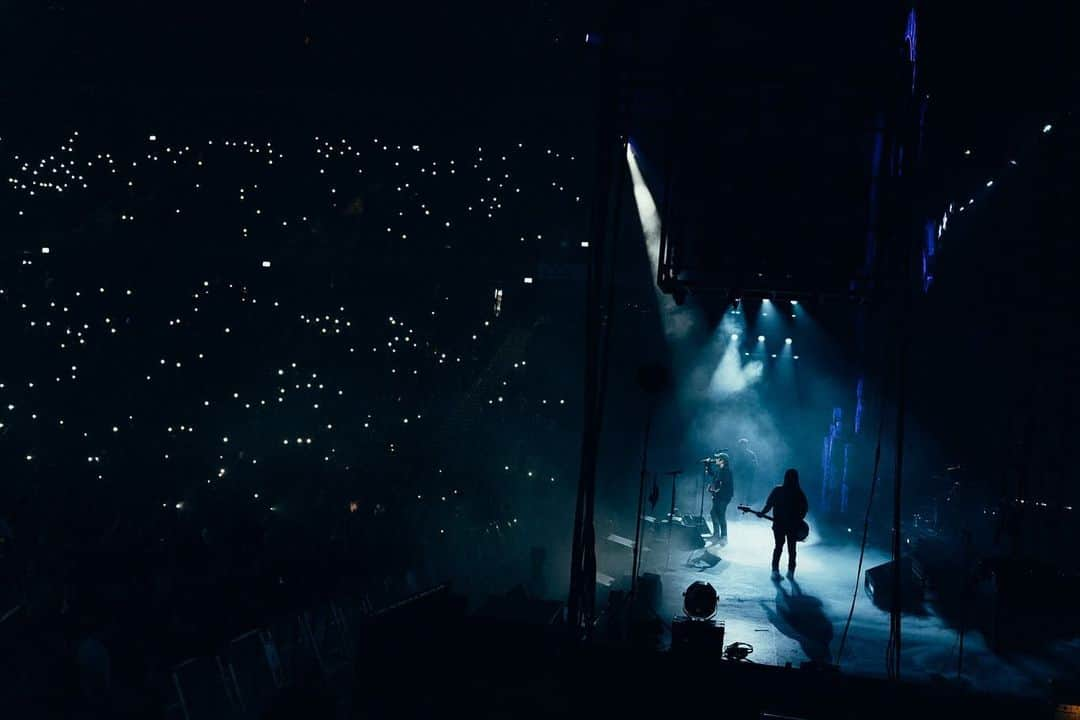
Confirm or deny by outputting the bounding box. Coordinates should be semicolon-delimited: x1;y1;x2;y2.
630;518;1080;696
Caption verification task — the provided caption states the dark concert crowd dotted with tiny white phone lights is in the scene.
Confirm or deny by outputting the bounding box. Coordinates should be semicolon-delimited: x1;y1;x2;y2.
0;117;586;708
